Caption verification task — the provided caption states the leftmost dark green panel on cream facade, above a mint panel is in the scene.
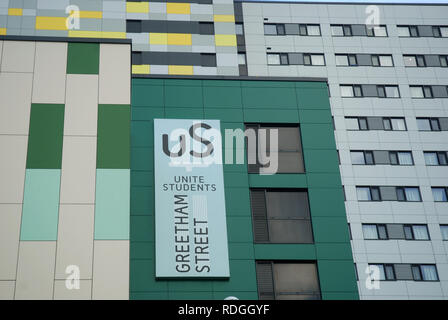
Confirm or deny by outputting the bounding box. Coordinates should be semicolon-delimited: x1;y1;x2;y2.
26;104;65;169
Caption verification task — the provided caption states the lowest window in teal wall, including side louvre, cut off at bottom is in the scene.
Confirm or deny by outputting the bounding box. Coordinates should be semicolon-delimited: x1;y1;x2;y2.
256;261;321;300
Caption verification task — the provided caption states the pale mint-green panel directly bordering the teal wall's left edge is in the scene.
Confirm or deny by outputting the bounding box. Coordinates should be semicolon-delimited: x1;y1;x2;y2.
95;169;131;240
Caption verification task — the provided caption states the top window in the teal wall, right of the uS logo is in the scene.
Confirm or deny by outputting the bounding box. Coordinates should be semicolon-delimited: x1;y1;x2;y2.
246;124;305;174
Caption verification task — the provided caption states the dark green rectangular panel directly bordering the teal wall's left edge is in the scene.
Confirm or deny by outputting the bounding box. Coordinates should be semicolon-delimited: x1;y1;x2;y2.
97;104;131;169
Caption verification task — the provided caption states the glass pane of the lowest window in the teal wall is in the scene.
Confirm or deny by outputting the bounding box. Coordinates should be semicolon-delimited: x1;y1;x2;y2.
274;263;320;295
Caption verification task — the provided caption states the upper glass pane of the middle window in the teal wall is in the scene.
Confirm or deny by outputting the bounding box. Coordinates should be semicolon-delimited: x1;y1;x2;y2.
266;191;310;219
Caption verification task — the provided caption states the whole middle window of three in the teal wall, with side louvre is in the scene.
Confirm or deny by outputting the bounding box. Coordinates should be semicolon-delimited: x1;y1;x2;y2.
250;189;313;243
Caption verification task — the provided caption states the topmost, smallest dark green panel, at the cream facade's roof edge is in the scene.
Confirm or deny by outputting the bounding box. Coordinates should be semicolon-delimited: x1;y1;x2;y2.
67;42;100;74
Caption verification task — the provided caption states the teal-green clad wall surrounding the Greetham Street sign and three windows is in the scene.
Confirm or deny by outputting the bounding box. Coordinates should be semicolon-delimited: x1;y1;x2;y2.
129;78;358;300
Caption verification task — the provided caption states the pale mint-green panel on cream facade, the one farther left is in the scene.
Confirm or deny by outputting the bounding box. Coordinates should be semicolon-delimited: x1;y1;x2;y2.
20;169;61;241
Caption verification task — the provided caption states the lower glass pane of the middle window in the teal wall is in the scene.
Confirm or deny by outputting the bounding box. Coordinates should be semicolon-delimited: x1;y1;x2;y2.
269;220;313;243
